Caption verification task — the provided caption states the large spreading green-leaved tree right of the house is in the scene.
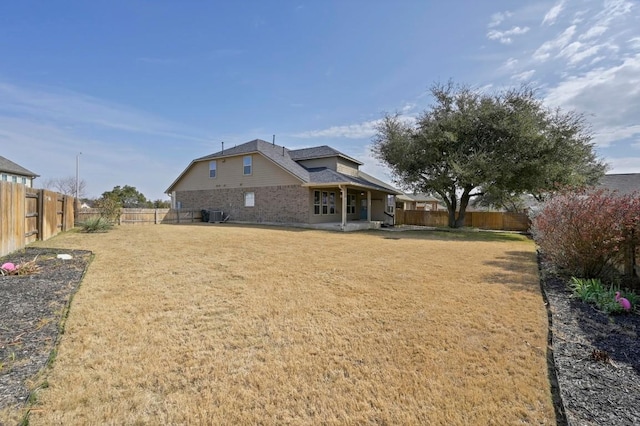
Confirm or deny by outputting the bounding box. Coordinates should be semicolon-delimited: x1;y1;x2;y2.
372;82;606;228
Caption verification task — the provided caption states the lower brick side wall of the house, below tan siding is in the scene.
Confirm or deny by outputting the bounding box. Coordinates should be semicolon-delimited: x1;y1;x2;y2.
176;185;311;223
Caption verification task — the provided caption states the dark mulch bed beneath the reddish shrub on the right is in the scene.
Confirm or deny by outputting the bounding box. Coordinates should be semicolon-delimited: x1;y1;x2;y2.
541;262;640;425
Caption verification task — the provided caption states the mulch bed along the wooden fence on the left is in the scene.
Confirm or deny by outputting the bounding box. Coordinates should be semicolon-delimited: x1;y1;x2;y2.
0;248;91;409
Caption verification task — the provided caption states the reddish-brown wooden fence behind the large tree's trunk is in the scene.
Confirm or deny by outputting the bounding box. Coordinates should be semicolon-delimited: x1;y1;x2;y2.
396;210;531;232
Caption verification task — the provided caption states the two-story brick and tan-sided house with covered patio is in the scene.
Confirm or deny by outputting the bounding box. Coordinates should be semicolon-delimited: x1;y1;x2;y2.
165;139;401;230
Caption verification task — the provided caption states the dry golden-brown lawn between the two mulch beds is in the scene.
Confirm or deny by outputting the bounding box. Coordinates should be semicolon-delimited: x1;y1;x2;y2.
20;224;555;425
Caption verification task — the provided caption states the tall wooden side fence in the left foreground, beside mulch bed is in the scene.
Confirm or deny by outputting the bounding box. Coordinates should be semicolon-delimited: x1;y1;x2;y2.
0;182;75;256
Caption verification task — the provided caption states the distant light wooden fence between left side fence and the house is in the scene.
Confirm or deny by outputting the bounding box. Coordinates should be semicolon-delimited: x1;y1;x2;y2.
78;209;202;225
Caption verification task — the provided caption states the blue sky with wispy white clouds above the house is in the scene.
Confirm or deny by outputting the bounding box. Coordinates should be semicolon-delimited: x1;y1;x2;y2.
0;0;640;199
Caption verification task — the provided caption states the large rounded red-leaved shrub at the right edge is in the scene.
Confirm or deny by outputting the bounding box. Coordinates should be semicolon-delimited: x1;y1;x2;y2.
531;189;640;279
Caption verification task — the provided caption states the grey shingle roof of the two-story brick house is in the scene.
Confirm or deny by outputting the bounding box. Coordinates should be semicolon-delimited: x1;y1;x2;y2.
166;139;400;194
